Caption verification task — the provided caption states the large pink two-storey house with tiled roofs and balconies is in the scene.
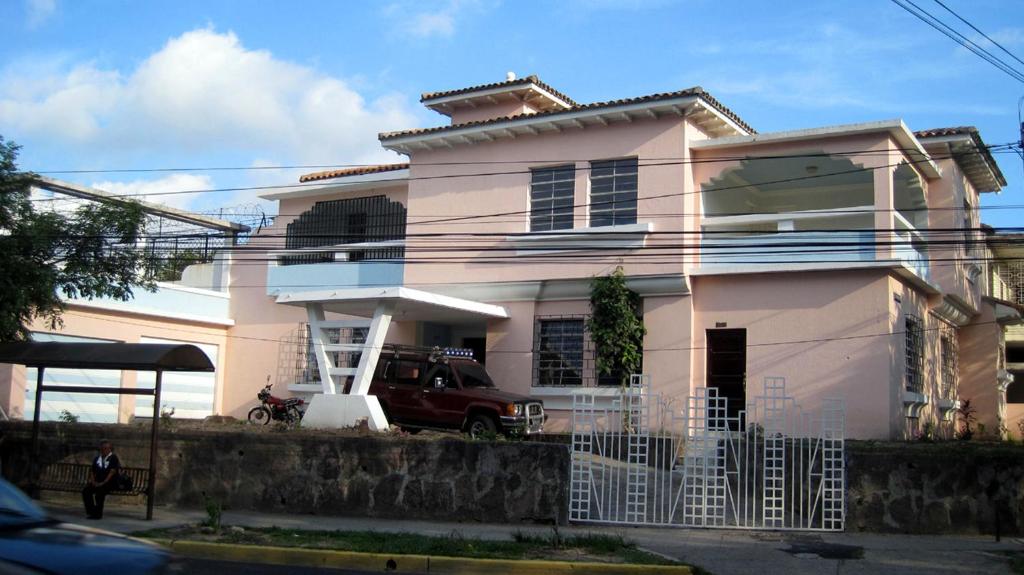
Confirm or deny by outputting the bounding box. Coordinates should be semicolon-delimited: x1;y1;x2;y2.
2;76;1020;439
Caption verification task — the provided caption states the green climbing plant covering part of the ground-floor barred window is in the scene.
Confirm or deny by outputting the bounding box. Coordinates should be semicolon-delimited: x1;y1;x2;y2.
587;266;647;386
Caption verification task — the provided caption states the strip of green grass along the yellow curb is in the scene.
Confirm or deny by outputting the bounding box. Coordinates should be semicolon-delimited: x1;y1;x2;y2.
135;527;681;565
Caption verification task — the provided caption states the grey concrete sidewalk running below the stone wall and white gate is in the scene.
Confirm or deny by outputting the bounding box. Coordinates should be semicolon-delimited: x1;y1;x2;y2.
43;500;1024;575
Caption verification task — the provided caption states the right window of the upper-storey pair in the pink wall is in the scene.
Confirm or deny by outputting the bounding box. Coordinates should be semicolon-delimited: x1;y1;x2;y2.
590;158;637;227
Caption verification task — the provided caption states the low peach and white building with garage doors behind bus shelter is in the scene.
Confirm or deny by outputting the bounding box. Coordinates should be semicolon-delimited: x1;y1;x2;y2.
0;178;249;423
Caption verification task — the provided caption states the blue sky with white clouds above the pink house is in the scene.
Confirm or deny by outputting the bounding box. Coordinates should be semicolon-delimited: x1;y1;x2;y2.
0;0;1024;226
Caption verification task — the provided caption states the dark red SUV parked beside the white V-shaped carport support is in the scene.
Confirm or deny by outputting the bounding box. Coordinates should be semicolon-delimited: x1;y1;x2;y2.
370;345;547;437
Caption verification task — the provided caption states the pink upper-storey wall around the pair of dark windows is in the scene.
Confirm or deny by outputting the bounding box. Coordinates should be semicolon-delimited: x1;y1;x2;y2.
406;118;686;283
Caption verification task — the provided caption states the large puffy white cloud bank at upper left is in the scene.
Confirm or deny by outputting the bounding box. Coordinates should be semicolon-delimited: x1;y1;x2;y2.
0;29;417;163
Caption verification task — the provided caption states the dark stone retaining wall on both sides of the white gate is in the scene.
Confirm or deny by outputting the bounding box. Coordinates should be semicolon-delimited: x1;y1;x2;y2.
0;423;1024;535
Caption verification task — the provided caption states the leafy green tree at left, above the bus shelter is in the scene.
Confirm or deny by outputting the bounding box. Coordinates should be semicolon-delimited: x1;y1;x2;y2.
0;136;154;341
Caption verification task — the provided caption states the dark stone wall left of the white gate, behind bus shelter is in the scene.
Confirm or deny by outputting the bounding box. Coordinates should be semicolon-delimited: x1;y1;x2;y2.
0;423;569;523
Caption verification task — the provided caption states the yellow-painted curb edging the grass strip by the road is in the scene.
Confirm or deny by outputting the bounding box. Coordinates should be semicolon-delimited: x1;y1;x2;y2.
151;539;692;575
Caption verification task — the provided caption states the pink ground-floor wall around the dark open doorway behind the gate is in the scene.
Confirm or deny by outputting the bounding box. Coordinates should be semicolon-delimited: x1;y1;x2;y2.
690;270;893;439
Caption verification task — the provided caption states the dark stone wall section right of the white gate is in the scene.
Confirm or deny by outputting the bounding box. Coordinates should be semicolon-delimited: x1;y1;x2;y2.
846;441;1024;535
